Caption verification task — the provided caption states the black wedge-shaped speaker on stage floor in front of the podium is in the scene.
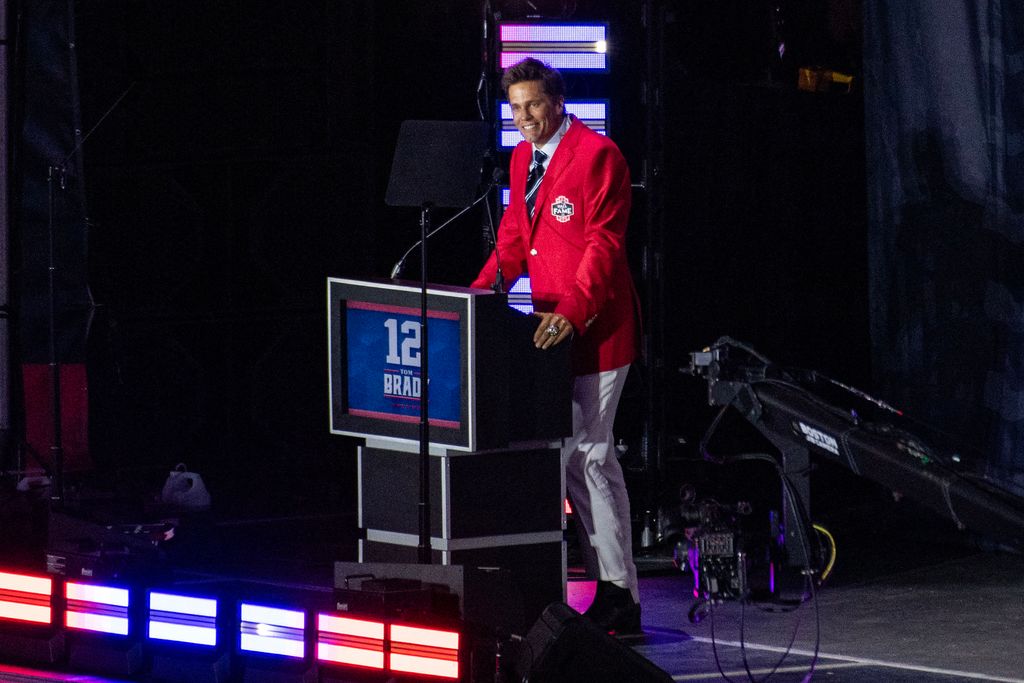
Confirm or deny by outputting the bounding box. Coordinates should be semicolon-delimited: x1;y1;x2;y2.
515;602;672;683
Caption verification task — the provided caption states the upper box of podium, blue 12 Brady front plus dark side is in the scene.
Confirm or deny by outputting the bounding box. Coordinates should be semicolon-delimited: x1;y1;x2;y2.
328;278;572;452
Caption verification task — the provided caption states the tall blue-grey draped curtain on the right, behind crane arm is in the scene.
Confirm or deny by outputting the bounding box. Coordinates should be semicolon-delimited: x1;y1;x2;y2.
864;0;1024;493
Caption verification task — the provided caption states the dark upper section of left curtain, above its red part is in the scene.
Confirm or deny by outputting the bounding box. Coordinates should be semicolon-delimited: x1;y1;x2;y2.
15;0;91;364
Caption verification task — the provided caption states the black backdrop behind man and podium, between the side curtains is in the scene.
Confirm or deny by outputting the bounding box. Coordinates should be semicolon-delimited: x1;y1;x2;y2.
46;0;869;509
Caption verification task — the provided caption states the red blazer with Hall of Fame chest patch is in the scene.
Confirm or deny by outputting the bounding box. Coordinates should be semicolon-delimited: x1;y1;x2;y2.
473;115;639;375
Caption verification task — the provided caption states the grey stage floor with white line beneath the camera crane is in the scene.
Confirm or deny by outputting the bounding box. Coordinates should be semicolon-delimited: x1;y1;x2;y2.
0;553;1024;683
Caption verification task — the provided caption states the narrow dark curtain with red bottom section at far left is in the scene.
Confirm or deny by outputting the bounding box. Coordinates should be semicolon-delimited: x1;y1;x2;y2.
11;0;92;474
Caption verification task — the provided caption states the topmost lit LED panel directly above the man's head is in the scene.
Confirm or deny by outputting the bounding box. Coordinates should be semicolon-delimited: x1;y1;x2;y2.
498;24;608;72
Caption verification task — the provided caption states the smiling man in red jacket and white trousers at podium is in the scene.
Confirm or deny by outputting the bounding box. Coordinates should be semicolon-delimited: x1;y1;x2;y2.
473;58;640;635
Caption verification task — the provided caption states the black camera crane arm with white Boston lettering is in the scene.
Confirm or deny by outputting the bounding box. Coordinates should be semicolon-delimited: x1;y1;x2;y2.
683;337;1024;566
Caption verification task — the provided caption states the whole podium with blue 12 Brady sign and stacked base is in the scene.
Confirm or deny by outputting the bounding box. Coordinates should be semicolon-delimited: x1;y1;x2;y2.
328;279;571;632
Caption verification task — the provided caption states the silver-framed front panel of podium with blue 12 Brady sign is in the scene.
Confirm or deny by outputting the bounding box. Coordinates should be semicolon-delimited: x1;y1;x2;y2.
328;278;507;451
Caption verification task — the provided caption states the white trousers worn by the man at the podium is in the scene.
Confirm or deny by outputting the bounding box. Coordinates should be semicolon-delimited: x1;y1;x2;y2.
562;366;640;602
